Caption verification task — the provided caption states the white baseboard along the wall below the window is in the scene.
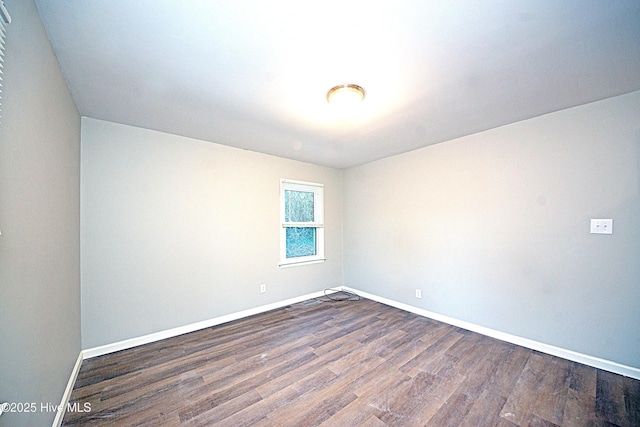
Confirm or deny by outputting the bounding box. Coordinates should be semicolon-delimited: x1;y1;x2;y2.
82;291;332;359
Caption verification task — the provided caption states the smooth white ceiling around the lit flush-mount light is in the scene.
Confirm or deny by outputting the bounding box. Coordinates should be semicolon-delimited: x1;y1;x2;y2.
36;0;640;168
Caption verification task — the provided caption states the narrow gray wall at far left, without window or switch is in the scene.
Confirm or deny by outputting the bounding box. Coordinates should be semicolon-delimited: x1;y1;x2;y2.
0;0;81;426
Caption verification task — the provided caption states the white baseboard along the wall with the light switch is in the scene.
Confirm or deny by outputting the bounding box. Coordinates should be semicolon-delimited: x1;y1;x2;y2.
341;286;640;380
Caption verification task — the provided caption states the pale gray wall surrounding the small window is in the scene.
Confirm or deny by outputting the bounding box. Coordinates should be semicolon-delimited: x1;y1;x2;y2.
81;118;342;348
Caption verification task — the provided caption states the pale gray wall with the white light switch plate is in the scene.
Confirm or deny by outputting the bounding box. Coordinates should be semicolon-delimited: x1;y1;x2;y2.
343;92;640;367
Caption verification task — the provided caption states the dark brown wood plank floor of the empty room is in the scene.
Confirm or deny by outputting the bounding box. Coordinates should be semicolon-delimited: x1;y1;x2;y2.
63;299;640;427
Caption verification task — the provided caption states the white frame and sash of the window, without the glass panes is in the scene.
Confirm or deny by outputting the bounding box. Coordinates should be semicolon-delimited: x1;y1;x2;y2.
279;179;326;268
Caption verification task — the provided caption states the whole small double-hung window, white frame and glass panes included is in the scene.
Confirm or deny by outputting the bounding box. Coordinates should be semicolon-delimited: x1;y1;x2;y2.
280;179;325;267
